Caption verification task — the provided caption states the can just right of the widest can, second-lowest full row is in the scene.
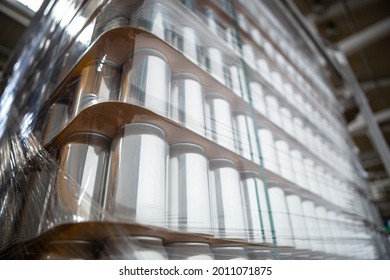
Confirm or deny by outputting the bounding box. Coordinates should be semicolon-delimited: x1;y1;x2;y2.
170;73;206;136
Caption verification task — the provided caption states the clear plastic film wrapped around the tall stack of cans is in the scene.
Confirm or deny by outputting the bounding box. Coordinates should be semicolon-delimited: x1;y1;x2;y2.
0;0;383;260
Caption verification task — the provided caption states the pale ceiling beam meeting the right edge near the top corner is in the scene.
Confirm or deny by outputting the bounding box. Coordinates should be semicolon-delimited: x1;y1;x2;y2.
337;17;390;55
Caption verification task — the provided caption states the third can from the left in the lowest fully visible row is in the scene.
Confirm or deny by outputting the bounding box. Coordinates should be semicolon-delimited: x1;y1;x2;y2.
167;143;212;234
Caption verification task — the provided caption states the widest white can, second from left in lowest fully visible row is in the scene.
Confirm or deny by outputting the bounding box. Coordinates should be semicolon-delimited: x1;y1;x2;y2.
106;123;169;227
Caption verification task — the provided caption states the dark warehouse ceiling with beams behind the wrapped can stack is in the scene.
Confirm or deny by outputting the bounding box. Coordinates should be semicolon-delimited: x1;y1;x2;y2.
0;0;390;219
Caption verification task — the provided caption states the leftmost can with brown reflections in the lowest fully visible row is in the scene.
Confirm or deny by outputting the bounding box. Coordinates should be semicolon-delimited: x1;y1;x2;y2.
51;133;111;221
